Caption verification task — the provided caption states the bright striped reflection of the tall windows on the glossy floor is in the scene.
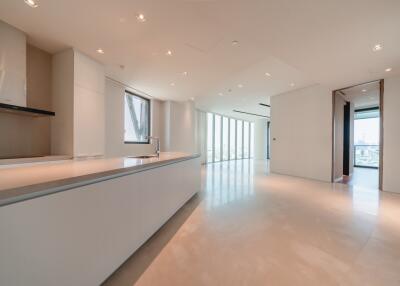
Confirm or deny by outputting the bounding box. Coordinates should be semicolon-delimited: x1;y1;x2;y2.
204;159;254;208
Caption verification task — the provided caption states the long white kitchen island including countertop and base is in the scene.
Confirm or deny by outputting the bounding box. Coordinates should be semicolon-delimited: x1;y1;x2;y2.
0;153;200;285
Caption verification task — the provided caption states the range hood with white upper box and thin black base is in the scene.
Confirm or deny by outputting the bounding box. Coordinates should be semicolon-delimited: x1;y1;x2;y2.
0;21;55;116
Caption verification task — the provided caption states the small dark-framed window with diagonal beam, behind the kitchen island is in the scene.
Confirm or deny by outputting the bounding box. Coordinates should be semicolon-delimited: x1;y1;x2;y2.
124;93;150;143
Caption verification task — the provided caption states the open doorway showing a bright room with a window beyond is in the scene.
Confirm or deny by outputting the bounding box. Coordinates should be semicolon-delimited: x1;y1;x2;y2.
332;80;384;189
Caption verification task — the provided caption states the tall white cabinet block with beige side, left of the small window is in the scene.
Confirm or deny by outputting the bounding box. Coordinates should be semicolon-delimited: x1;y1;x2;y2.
51;49;105;157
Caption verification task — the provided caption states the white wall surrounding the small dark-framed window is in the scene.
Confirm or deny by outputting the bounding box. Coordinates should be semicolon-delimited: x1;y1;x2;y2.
106;79;163;157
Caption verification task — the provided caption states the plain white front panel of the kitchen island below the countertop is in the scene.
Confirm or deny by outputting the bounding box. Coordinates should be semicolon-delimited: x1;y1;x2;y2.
0;158;200;286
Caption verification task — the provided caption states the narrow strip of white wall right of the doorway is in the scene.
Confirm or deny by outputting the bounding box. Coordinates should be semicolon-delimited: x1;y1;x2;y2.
383;76;400;193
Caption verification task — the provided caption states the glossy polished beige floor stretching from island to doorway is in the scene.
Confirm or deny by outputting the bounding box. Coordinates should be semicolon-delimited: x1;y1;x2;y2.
104;160;400;286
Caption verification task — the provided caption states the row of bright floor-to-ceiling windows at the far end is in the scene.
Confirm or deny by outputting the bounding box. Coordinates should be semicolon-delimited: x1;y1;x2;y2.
207;113;254;163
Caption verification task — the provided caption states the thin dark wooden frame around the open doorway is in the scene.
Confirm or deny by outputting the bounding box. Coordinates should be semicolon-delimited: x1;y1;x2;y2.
331;79;385;190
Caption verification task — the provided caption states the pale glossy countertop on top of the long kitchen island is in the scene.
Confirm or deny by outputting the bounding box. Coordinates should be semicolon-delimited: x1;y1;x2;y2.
0;152;198;206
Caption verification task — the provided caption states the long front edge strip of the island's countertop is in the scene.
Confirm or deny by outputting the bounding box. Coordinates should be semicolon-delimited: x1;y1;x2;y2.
0;154;200;207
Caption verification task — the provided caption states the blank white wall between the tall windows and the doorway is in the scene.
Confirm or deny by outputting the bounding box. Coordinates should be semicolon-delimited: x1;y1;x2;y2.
271;85;332;181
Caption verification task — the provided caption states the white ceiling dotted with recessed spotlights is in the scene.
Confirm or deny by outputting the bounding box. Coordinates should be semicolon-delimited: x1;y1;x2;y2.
0;0;400;117
